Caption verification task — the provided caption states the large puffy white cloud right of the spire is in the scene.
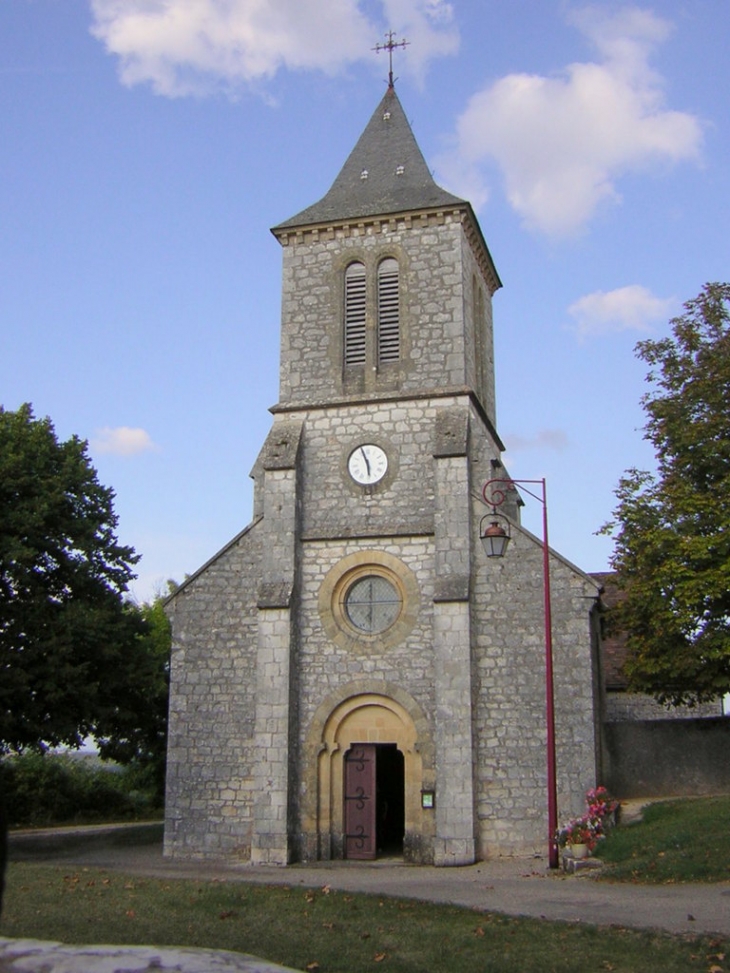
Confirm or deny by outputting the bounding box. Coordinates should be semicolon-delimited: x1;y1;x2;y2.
438;7;702;236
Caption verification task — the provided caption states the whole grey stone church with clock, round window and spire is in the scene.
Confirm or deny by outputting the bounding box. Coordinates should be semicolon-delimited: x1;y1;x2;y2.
165;79;600;865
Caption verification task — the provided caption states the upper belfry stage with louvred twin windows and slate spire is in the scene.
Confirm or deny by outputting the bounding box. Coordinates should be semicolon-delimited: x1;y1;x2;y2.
272;87;501;425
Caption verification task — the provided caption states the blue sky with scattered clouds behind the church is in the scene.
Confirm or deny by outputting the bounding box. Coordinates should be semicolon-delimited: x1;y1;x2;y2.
0;0;730;601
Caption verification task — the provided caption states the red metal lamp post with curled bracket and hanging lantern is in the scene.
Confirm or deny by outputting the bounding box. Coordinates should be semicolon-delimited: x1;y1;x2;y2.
479;479;558;868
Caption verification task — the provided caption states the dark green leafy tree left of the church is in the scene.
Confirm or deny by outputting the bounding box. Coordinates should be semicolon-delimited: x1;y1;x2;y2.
0;405;145;753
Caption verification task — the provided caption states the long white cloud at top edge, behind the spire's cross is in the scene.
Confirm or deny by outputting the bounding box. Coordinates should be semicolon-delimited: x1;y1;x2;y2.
91;0;458;97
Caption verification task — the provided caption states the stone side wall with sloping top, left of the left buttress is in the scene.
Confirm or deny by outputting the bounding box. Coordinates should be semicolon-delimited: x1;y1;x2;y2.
165;525;261;859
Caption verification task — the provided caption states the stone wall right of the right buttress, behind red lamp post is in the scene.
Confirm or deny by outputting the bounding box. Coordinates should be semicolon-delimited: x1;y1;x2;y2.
472;416;598;857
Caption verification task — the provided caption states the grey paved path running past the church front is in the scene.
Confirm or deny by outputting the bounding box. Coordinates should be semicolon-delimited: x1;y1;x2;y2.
0;829;730;973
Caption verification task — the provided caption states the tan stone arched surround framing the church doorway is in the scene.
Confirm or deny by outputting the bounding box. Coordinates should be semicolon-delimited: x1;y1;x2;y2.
302;679;435;863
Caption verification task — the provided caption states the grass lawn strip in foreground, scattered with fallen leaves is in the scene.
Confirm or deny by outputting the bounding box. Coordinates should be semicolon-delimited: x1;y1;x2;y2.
0;862;730;973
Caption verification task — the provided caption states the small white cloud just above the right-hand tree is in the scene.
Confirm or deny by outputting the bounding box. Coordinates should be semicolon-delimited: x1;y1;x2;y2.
568;284;676;338
